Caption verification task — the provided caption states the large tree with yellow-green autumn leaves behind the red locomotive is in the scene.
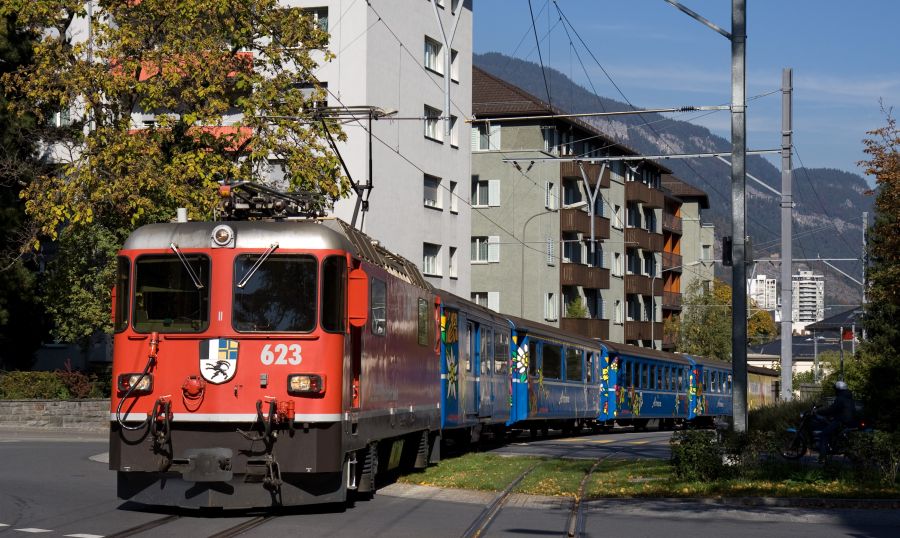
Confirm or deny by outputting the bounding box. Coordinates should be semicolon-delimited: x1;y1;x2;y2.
0;0;350;338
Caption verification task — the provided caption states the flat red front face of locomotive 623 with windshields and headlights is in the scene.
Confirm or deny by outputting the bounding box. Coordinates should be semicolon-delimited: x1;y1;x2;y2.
110;222;368;507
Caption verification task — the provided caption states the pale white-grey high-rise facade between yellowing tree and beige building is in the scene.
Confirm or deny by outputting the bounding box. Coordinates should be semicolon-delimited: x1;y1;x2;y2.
294;0;472;297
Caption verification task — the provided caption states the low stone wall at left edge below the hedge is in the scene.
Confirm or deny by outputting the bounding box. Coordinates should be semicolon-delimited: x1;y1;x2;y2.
0;399;109;432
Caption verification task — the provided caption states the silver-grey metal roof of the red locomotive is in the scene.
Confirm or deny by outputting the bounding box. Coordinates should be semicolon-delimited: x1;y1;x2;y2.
122;219;432;291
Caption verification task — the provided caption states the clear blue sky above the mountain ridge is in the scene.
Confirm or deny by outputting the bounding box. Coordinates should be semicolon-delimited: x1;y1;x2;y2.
474;0;900;182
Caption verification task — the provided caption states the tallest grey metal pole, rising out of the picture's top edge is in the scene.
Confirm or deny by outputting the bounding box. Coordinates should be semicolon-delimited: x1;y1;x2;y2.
731;0;747;433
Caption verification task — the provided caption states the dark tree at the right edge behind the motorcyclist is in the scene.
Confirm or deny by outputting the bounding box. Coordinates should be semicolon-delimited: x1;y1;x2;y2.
857;112;900;430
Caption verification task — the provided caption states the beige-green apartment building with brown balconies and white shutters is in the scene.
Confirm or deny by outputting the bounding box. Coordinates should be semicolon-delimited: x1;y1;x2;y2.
471;68;712;348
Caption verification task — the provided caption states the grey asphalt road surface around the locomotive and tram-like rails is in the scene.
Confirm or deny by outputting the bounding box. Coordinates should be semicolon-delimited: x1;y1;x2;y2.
0;431;900;538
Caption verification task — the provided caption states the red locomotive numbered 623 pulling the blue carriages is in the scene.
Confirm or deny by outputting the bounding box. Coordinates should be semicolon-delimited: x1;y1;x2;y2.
110;182;440;508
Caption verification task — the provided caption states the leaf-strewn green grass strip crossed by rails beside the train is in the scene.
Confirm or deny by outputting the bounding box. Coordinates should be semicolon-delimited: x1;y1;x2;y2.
400;453;900;499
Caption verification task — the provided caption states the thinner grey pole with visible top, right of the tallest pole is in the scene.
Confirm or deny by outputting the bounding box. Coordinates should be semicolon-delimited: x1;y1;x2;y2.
781;68;796;401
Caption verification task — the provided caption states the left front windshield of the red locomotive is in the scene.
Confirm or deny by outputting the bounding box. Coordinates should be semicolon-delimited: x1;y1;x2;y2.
132;254;209;333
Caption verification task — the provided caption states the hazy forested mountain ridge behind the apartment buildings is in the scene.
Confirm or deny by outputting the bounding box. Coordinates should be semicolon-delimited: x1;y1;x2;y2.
473;53;874;308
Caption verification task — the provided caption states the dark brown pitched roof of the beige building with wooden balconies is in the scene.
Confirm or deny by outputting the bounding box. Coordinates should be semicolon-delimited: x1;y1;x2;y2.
472;66;670;174
